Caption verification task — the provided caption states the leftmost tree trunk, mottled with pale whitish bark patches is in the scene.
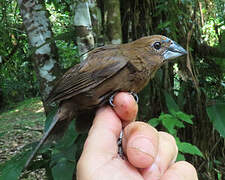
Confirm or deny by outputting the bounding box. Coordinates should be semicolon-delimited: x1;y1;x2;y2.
18;0;60;113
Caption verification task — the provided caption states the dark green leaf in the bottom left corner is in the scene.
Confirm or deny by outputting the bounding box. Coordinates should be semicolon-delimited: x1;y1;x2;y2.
0;151;31;180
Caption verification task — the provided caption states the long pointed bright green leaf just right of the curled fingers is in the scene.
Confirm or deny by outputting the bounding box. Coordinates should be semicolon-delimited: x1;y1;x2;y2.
177;142;204;158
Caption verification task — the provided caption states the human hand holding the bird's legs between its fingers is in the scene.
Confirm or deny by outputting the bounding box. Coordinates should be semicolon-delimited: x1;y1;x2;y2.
77;92;198;180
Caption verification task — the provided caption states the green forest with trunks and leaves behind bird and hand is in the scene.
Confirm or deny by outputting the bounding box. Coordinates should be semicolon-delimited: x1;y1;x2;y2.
0;0;225;180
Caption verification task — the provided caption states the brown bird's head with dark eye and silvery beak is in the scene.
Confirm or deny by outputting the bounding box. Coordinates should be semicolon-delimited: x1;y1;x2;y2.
125;35;187;62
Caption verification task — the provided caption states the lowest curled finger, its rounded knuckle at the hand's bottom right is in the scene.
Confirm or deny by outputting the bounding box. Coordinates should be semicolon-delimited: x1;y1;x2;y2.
160;161;198;180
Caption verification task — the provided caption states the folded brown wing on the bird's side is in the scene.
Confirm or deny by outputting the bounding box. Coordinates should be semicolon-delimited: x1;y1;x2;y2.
47;46;127;102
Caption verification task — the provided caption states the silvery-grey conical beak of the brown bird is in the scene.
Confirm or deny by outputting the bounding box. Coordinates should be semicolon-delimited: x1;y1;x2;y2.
163;40;187;60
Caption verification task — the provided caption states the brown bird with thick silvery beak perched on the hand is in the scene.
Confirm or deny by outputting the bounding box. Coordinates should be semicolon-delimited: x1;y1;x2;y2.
26;35;186;167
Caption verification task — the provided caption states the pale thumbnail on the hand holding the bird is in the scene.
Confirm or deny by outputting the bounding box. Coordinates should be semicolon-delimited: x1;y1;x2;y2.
129;136;156;159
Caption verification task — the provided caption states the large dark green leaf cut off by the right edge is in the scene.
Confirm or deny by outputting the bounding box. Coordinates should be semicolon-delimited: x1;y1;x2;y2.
206;103;225;137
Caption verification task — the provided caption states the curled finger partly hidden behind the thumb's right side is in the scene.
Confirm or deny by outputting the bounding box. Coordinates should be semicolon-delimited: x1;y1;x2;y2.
141;132;178;179
